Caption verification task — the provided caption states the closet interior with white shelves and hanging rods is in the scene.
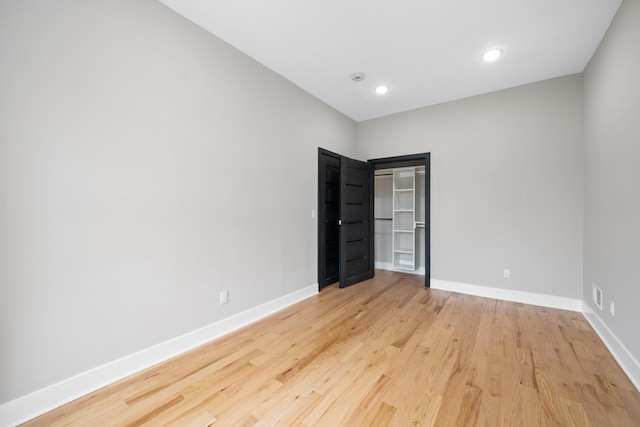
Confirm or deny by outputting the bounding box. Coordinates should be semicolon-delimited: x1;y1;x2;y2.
374;166;426;274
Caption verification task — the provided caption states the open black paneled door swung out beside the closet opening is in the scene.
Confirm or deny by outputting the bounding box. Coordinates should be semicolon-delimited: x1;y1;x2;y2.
340;156;374;288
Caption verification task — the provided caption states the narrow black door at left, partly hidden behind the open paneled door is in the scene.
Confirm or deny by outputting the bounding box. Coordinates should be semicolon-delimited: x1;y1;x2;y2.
318;149;340;289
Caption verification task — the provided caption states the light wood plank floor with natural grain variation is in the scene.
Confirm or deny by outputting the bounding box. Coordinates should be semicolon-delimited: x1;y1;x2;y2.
22;271;640;427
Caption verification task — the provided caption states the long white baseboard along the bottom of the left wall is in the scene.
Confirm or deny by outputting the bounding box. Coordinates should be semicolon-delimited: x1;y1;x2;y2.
0;284;318;426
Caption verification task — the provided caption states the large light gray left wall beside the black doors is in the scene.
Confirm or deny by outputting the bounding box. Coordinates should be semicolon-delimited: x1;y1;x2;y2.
0;0;356;403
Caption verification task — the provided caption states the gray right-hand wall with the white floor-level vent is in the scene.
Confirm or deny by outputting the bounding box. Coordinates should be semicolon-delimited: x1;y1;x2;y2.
584;0;640;360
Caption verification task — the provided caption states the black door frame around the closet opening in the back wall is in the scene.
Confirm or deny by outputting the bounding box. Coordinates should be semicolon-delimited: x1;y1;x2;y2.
368;153;431;288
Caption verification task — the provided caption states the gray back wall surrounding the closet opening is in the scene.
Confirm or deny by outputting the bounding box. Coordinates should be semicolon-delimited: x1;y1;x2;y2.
358;75;583;299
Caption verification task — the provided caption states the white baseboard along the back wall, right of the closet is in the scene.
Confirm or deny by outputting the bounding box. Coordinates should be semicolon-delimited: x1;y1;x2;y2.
431;279;582;311
